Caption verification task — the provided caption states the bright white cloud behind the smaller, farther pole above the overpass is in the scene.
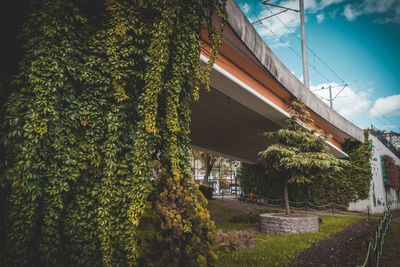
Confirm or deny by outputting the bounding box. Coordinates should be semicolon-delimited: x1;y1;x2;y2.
310;83;372;120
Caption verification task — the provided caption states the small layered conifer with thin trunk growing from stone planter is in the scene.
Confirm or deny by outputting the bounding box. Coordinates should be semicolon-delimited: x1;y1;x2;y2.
259;100;347;214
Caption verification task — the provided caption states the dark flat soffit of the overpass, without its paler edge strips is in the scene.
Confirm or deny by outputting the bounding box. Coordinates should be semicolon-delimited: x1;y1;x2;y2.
191;88;280;164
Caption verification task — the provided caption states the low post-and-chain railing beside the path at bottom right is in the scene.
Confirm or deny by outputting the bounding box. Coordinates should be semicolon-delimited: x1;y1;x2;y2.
353;207;392;267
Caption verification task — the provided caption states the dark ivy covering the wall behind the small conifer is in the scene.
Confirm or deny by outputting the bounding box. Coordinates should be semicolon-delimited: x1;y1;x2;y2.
239;131;372;206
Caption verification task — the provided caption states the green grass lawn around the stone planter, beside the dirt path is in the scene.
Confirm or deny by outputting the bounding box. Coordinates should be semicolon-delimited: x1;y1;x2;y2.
208;200;363;266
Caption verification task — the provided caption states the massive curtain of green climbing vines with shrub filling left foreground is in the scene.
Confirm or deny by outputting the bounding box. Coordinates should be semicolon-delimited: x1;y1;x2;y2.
0;0;225;266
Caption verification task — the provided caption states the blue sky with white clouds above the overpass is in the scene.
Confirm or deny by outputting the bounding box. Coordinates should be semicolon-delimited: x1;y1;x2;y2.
237;0;400;132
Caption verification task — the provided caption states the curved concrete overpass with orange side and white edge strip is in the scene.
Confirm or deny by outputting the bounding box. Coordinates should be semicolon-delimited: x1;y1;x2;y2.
191;0;364;163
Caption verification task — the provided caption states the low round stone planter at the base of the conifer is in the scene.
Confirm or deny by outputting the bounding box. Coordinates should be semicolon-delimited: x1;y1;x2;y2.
260;213;318;234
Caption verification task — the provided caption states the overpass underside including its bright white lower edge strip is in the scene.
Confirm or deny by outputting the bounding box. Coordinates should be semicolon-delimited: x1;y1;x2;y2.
191;66;347;164
